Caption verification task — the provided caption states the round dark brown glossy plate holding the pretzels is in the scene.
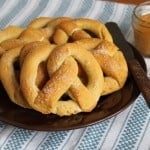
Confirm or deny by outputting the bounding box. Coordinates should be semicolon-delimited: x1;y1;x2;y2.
0;42;146;131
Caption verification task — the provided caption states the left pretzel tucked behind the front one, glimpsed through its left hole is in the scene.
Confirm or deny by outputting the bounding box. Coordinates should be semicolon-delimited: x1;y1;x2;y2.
0;42;48;108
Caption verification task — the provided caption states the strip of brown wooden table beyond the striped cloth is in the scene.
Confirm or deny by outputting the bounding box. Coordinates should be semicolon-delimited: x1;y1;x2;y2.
104;0;148;5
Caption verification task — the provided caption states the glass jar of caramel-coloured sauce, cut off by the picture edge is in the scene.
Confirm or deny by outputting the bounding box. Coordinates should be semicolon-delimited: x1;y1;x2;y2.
132;1;150;57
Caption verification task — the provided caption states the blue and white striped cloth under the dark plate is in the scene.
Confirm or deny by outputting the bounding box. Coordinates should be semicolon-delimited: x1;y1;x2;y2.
0;0;150;150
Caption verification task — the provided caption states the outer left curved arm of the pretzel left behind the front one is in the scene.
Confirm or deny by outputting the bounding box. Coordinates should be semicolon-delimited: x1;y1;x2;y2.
0;46;29;108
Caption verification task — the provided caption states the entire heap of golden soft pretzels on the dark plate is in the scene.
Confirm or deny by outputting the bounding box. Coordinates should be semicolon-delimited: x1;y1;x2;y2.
0;17;128;116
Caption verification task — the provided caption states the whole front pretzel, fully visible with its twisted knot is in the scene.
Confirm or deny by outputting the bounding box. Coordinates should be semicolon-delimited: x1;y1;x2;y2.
20;43;104;116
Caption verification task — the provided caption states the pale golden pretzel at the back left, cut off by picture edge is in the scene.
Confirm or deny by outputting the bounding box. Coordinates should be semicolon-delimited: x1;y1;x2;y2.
0;26;49;56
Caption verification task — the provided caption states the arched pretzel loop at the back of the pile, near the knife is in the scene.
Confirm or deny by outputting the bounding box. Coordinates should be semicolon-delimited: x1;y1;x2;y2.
53;18;113;44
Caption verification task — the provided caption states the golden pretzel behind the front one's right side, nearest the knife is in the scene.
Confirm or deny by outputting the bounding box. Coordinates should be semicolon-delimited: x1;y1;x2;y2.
75;38;128;95
